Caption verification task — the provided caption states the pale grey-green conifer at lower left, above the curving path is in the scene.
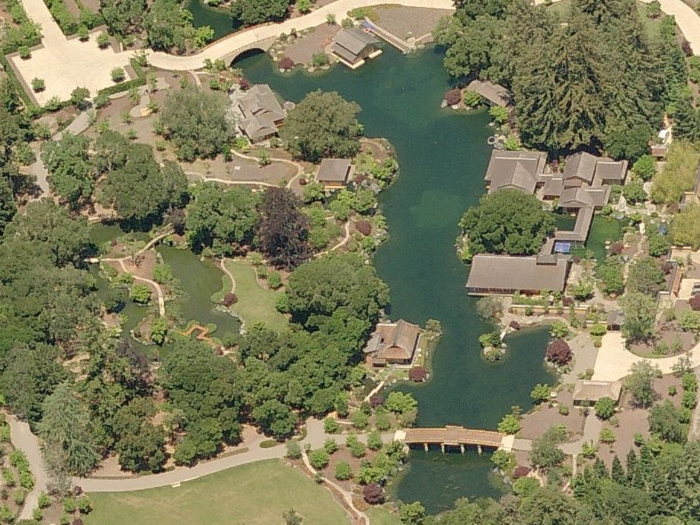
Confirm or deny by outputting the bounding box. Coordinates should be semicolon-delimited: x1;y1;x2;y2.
38;383;100;479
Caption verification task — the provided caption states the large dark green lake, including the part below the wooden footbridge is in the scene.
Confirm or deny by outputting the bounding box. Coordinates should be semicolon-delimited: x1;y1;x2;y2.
236;47;554;512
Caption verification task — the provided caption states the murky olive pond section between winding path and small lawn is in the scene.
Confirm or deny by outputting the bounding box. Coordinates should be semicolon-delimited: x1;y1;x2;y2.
156;245;241;338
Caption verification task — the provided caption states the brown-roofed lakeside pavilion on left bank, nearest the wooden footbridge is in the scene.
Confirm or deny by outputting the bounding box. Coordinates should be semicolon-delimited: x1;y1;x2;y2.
363;319;420;366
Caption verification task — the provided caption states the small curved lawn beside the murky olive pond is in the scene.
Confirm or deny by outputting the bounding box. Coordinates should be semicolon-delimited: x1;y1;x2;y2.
226;261;287;330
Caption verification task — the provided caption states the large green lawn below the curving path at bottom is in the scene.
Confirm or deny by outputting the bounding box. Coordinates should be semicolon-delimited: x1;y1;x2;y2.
84;459;350;525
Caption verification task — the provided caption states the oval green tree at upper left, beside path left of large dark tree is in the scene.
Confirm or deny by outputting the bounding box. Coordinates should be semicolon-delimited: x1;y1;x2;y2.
41;132;95;208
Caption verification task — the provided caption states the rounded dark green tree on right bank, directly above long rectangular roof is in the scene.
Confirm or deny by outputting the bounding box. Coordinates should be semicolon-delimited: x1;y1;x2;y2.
459;189;554;255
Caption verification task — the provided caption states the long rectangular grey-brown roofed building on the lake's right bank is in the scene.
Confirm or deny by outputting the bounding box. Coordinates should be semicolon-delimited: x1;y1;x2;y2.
467;254;571;295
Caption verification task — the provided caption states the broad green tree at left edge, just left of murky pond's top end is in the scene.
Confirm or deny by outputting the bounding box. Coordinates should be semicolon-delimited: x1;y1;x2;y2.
5;199;90;266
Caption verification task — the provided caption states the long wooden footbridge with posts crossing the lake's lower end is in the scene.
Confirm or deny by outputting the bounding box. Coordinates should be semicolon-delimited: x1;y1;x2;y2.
394;425;512;453
